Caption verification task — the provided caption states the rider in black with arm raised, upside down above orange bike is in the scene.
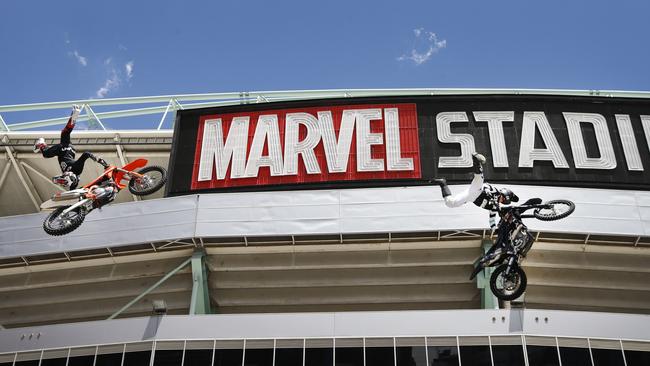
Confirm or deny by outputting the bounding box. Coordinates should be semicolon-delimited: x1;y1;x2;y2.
34;105;108;189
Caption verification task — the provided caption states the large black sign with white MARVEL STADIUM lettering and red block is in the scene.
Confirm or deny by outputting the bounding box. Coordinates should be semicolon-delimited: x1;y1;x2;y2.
168;96;650;195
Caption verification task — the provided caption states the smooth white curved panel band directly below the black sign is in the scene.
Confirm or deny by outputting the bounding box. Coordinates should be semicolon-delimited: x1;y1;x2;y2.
0;186;650;257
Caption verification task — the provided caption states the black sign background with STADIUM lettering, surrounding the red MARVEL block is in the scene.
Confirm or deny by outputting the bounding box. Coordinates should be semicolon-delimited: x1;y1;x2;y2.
167;95;650;195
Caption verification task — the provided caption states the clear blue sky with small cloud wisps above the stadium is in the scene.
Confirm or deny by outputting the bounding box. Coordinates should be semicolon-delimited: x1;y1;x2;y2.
0;0;650;105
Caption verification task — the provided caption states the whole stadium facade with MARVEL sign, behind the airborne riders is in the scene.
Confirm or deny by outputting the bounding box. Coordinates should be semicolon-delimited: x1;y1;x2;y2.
0;89;650;366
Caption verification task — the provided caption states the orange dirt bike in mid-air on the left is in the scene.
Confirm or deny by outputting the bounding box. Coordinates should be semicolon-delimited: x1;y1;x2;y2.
41;159;167;235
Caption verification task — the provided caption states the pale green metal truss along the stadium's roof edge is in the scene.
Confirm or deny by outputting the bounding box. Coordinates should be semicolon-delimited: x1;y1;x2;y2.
0;88;650;131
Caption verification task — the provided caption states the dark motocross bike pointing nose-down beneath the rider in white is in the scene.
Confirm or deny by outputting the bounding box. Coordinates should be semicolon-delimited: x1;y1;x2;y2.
470;198;575;301
